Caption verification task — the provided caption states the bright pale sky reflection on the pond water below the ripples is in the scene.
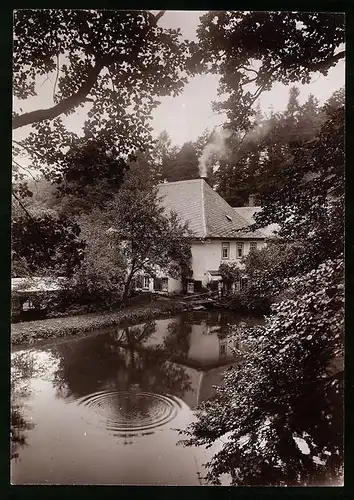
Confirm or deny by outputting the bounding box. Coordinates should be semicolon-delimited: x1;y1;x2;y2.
12;379;220;485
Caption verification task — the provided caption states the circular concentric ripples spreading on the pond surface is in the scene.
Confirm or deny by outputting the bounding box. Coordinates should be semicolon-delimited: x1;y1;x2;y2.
78;391;181;436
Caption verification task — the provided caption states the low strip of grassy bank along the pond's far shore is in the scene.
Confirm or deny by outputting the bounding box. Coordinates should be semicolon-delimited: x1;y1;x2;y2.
11;301;194;345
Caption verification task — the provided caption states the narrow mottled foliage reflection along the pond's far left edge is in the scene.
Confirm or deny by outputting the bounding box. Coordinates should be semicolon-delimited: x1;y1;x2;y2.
10;351;34;460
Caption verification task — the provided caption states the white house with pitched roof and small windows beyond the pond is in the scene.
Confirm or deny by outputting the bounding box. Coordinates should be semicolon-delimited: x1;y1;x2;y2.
138;178;269;293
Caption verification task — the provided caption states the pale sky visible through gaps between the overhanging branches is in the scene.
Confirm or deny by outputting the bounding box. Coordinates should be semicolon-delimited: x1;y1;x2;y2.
13;11;345;166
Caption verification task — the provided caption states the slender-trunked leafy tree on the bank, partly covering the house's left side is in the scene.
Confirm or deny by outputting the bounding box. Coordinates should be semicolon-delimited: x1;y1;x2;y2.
99;161;191;300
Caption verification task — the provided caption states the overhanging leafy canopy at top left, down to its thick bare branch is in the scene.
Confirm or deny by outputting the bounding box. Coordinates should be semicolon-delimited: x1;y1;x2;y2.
13;9;187;128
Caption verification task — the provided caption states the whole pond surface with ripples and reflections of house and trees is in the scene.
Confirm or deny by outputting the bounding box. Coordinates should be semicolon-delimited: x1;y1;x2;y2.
11;311;260;486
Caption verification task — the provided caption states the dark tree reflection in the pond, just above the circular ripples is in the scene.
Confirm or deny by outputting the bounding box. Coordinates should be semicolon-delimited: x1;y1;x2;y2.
51;322;191;398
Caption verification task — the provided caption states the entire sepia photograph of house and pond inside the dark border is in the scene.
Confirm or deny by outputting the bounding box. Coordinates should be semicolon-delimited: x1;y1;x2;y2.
9;9;346;487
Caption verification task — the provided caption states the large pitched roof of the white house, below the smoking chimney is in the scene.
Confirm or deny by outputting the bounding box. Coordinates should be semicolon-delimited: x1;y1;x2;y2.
158;179;265;239
